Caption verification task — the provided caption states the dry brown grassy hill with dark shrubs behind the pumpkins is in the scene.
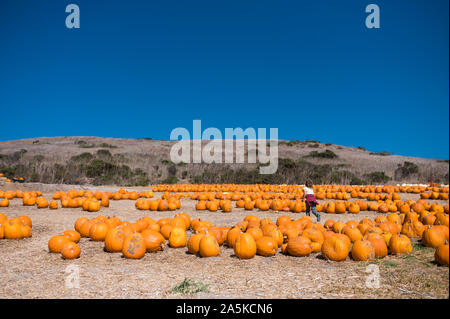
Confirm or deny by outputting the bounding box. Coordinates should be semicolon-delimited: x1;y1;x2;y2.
0;137;449;186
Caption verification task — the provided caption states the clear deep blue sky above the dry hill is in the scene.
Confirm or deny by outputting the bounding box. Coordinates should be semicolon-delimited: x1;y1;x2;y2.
0;0;449;159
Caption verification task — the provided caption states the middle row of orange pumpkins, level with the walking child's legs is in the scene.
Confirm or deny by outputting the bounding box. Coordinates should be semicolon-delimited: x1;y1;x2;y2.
0;191;449;218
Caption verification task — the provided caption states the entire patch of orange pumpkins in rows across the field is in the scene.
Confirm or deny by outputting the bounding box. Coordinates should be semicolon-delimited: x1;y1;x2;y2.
0;185;449;300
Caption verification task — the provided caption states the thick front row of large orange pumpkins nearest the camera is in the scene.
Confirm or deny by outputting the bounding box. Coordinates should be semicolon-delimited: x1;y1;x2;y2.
44;212;449;266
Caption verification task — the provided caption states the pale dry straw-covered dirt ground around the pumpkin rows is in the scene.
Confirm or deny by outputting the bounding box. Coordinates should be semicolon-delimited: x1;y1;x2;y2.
0;184;449;298
